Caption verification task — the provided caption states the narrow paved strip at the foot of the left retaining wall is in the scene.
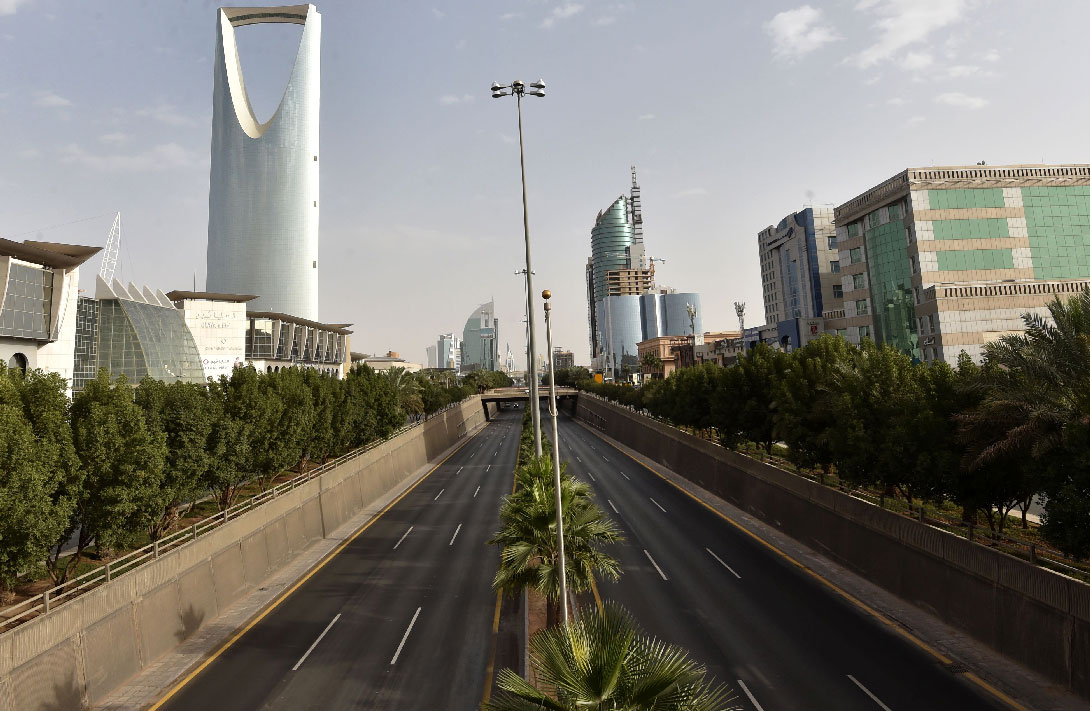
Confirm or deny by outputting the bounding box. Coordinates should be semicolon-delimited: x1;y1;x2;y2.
94;422;489;711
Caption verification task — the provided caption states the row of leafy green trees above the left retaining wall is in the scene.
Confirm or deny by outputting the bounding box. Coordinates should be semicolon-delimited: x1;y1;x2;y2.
0;365;483;591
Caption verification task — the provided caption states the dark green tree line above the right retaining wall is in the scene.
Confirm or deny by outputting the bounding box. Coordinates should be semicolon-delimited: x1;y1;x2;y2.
584;289;1090;557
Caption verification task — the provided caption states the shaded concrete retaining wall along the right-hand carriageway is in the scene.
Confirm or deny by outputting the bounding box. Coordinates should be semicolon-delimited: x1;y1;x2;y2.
576;395;1090;698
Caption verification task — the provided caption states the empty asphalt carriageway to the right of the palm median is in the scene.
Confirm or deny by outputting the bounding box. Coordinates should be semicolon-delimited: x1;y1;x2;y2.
559;407;1007;711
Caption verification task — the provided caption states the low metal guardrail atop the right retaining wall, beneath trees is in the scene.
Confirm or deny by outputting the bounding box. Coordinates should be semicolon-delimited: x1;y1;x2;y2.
579;390;1090;583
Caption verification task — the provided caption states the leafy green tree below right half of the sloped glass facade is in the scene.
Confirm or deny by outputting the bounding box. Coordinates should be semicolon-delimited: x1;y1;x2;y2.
135;377;216;541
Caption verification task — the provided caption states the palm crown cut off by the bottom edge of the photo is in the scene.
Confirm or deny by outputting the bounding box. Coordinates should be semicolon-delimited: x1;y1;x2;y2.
482;602;741;711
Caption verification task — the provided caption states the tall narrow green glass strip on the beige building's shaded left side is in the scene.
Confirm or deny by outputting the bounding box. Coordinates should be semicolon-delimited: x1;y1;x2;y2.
852;208;919;359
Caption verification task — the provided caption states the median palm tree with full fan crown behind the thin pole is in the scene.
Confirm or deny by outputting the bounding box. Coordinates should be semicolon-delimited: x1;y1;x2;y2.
488;457;621;626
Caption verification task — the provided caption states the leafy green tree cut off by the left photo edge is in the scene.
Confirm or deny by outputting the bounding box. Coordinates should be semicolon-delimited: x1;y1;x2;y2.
0;366;73;596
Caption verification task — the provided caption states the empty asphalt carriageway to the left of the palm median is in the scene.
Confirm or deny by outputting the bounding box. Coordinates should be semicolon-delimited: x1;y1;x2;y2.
155;409;522;711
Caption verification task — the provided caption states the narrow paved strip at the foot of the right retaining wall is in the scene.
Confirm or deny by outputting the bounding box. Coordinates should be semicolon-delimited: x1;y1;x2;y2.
574;420;1090;711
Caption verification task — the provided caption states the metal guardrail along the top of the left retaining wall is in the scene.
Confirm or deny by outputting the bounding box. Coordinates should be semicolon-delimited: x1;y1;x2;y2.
0;398;469;631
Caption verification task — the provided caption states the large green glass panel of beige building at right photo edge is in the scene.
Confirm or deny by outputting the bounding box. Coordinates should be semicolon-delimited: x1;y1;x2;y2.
1021;185;1090;279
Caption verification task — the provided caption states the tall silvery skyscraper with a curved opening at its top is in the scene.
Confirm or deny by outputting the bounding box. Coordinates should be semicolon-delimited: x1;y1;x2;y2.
206;4;322;321
